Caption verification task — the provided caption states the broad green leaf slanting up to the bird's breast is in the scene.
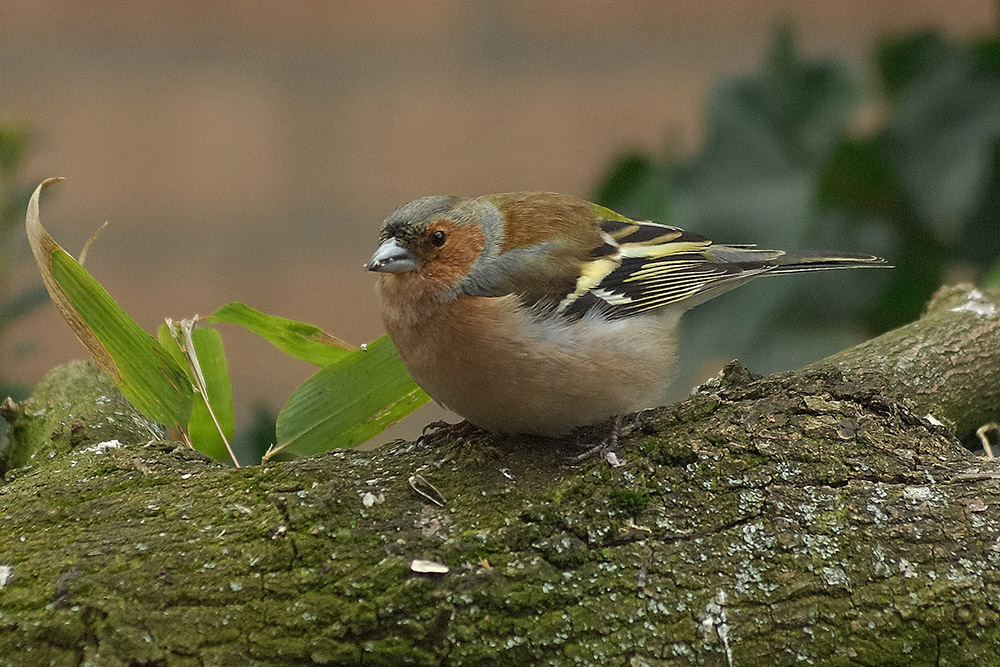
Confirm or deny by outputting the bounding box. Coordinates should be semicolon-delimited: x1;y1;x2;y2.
265;336;430;458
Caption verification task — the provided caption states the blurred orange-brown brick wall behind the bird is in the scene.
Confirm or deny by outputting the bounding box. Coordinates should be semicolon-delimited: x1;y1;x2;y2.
0;0;995;440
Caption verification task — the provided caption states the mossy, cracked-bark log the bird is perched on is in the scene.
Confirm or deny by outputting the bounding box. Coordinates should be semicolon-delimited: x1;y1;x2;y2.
0;284;1000;665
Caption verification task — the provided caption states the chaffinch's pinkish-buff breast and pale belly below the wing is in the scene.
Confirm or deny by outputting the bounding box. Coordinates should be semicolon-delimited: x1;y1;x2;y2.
386;297;680;435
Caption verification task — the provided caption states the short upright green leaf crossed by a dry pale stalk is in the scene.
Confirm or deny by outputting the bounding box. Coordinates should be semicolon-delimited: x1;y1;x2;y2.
158;322;239;466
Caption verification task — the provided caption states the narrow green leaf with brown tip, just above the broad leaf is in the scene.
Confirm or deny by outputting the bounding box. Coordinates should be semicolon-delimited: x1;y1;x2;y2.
205;302;356;366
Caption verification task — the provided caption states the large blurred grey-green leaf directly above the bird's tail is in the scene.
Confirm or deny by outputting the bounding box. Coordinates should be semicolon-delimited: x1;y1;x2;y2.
676;28;858;253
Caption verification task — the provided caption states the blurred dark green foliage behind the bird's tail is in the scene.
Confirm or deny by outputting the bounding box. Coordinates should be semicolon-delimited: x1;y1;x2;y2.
595;28;1000;396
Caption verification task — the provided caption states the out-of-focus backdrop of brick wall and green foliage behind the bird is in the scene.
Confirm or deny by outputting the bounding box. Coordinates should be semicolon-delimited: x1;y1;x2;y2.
0;0;1000;454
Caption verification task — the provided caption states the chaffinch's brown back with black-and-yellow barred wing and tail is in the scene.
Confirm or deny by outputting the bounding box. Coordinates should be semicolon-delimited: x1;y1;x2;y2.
464;194;886;318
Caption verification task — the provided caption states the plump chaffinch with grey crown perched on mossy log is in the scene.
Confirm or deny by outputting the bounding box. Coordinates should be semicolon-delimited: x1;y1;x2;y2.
367;192;885;435
